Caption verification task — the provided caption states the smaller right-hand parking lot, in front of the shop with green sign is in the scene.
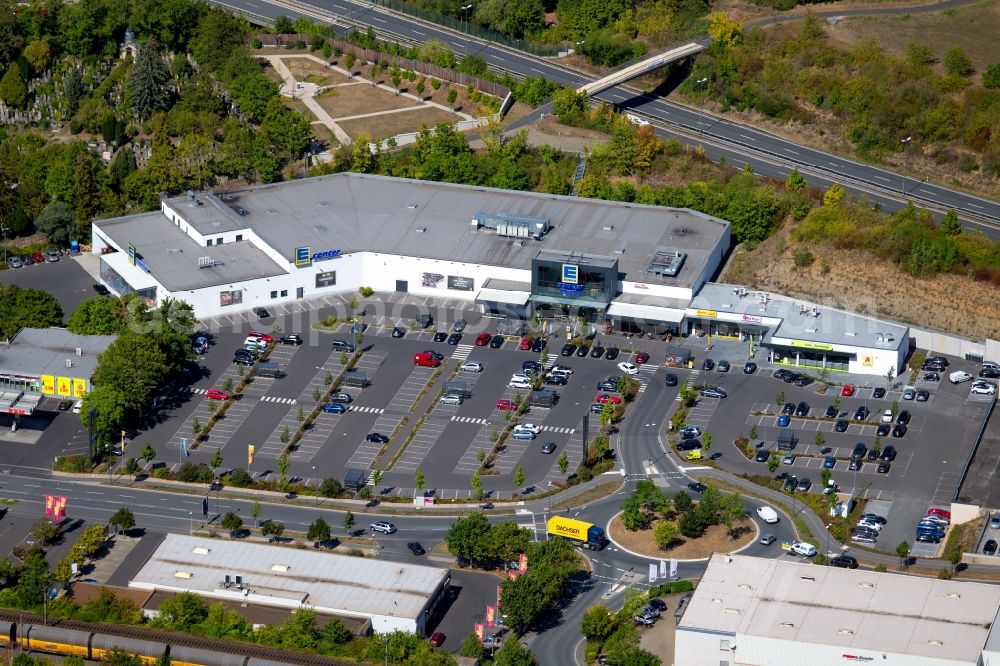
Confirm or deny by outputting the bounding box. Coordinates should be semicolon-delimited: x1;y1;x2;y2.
688;354;991;555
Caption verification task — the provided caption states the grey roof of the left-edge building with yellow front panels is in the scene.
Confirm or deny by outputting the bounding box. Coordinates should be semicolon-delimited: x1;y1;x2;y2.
0;328;118;377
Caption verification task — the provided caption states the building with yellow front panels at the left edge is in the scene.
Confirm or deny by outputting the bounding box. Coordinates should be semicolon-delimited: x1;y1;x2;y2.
0;328;116;416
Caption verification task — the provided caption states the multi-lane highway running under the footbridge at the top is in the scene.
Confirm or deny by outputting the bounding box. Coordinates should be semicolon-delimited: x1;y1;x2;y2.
213;0;1000;238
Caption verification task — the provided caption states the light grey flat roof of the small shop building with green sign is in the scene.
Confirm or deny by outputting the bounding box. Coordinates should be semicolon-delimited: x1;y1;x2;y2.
688;282;910;349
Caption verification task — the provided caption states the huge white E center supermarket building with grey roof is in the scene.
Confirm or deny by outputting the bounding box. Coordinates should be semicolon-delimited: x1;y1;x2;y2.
93;173;730;331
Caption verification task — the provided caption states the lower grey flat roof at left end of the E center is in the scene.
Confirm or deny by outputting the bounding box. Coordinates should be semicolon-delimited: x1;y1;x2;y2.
94;213;288;292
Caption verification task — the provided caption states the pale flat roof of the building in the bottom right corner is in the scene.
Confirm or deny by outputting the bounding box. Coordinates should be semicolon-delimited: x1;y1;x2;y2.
678;554;1000;662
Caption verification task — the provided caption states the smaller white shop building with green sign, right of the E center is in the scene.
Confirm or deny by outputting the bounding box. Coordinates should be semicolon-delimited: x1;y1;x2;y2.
685;282;910;377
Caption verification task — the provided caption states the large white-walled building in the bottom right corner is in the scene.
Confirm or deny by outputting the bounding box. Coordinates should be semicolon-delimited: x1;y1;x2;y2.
674;555;1000;666
